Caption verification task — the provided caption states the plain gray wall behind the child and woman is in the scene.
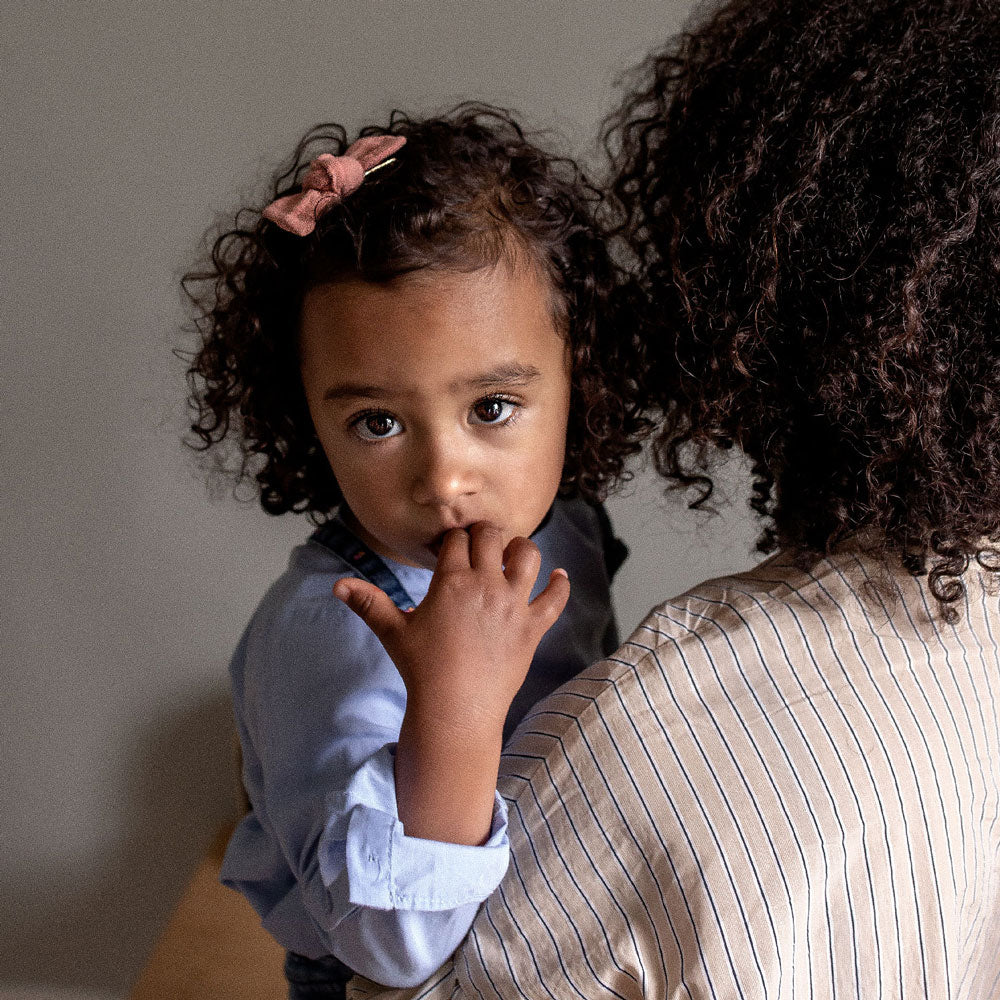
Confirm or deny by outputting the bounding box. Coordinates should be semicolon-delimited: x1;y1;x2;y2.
0;0;750;996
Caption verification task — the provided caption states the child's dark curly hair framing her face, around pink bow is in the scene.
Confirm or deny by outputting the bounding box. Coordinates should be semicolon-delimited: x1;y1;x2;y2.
183;103;649;521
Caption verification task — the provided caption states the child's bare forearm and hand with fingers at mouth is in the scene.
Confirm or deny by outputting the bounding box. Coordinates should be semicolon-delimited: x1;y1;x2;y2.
334;523;569;844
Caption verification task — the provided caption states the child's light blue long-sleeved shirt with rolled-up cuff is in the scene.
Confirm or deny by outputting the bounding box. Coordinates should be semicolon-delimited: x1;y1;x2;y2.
222;500;617;986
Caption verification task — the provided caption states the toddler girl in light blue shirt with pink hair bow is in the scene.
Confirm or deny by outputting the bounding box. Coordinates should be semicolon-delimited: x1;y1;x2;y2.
185;105;645;997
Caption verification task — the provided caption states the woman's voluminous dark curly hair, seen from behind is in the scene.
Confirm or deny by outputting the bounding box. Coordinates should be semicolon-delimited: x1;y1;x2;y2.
606;0;1000;620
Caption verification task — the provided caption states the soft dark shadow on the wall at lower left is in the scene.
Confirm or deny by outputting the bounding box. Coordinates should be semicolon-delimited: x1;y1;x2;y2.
0;689;237;996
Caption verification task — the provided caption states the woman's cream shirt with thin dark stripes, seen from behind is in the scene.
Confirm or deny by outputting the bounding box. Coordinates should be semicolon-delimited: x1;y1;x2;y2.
353;553;1000;1000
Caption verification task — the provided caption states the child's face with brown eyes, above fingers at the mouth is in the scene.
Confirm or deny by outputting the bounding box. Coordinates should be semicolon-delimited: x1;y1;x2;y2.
300;263;570;568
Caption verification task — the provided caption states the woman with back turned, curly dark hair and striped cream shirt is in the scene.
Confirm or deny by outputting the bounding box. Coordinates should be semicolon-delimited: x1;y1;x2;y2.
364;0;1000;1000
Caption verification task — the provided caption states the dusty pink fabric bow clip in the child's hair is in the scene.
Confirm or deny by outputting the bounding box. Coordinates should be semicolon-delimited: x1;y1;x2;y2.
264;135;406;236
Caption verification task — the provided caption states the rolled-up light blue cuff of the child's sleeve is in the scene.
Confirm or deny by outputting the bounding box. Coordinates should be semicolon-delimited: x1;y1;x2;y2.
320;747;510;910
